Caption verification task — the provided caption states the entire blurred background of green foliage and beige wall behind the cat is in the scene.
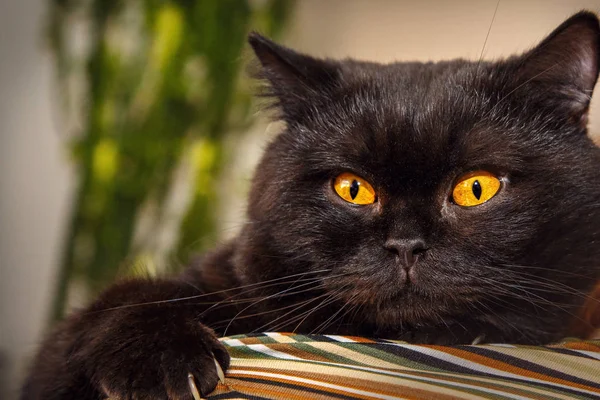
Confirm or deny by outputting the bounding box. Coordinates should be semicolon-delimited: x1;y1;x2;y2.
0;0;600;399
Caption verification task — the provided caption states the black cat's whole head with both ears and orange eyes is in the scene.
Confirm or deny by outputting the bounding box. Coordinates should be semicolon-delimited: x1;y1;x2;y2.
242;13;600;340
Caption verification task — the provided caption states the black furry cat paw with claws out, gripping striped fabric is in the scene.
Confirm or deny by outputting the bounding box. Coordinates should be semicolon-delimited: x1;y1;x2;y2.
84;314;229;400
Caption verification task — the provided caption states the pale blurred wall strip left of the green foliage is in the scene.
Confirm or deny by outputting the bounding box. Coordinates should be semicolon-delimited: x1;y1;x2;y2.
0;0;70;399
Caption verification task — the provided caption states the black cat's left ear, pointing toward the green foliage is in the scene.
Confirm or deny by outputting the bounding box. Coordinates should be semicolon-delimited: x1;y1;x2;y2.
248;32;340;118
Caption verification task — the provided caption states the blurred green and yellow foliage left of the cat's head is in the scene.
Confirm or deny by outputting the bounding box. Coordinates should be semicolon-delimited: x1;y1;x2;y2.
49;0;292;320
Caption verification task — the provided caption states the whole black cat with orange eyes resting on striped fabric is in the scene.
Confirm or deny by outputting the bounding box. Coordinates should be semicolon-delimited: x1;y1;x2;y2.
22;12;600;399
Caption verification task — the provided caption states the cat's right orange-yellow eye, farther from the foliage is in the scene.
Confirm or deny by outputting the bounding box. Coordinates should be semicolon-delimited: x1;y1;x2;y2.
452;171;501;207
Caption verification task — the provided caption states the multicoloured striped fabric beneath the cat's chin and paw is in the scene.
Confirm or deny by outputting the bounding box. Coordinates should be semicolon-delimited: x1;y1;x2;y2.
208;333;600;400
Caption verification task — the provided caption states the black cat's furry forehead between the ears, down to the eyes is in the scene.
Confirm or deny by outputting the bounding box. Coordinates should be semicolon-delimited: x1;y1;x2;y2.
286;61;525;179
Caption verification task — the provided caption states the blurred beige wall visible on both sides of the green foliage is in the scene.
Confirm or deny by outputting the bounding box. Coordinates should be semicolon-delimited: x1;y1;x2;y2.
0;0;600;399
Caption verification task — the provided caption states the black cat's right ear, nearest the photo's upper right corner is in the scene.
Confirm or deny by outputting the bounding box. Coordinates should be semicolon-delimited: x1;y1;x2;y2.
510;11;600;126
